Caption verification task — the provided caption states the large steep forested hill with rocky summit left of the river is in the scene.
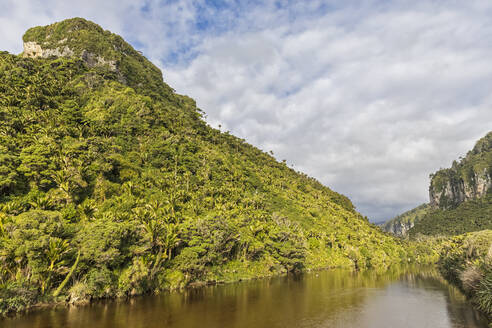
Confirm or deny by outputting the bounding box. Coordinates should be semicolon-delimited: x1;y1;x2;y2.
0;18;411;312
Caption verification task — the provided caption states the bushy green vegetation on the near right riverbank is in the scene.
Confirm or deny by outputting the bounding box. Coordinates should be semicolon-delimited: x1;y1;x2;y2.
438;230;492;317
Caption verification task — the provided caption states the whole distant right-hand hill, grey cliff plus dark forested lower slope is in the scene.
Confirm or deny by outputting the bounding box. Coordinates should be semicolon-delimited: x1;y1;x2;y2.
382;132;492;237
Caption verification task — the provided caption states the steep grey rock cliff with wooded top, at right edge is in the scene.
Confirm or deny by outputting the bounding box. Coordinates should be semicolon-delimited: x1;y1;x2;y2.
429;132;492;209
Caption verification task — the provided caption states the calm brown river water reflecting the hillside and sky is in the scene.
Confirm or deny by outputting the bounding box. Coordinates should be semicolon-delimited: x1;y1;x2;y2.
0;268;487;328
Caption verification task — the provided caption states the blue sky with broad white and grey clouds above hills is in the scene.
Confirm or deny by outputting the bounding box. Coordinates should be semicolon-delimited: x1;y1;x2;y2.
0;0;492;221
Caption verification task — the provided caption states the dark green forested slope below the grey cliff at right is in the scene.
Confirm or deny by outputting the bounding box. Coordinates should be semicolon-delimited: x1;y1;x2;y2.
409;194;492;237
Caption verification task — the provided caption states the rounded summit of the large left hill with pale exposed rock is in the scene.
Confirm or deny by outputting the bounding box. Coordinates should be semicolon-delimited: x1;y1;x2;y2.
22;18;169;92
